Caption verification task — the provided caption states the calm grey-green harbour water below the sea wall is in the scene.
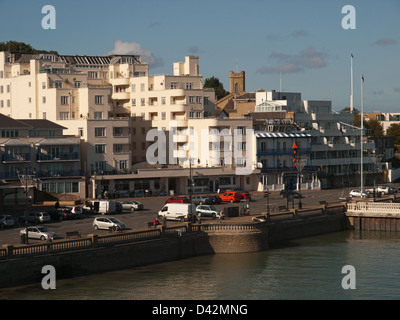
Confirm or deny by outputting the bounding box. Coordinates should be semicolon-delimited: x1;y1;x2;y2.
0;231;400;300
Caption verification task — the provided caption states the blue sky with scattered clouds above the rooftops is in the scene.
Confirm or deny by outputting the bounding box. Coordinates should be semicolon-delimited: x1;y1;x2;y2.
0;0;400;112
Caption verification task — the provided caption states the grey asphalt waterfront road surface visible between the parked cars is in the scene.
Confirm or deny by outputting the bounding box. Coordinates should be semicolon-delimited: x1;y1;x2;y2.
0;188;351;246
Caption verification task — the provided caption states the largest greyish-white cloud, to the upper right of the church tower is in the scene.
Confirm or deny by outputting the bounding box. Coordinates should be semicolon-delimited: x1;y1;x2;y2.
257;47;327;73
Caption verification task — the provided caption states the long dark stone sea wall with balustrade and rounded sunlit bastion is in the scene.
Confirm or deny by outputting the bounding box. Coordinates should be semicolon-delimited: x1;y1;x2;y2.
0;208;347;287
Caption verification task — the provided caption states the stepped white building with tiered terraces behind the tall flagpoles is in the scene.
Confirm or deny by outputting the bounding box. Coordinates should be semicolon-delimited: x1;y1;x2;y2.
256;91;375;187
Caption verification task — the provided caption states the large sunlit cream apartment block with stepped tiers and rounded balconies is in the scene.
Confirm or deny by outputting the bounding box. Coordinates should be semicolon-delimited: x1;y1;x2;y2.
0;52;264;196
